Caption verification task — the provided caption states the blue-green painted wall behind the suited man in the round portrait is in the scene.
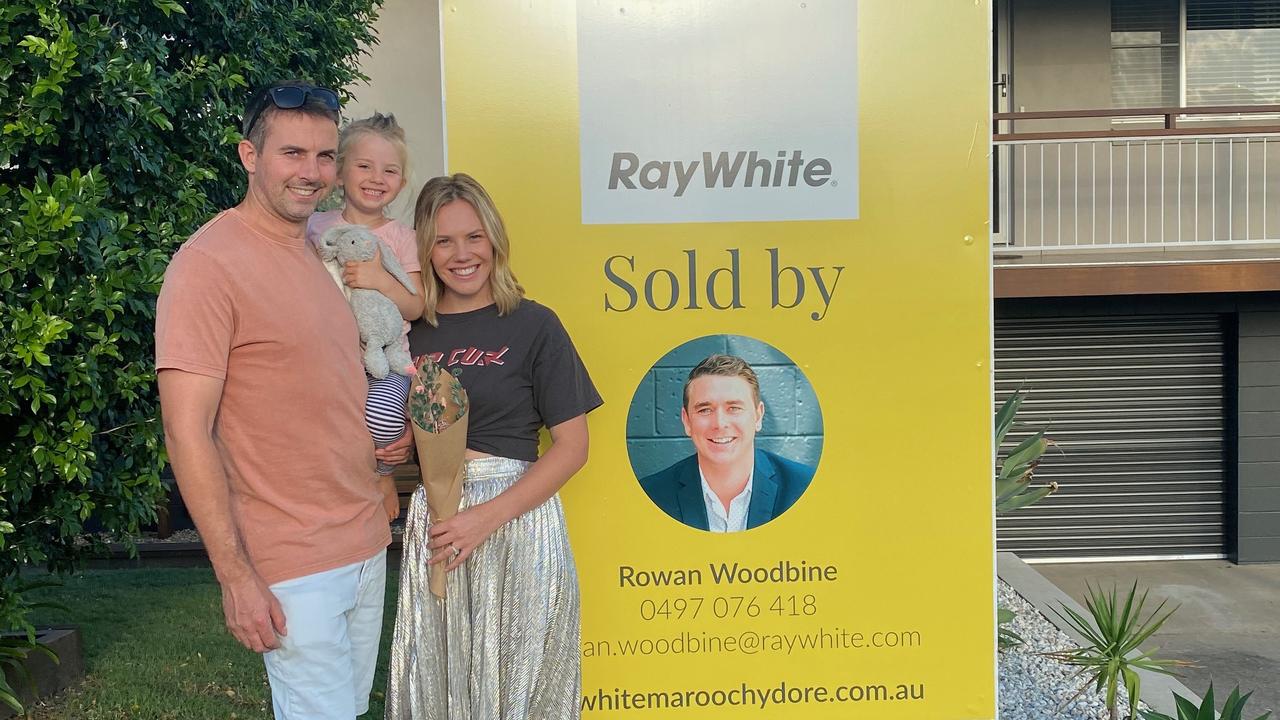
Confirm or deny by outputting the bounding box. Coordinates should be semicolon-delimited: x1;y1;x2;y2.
627;334;822;478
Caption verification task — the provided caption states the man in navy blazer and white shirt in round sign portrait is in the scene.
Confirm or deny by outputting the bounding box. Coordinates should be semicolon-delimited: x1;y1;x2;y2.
640;355;814;533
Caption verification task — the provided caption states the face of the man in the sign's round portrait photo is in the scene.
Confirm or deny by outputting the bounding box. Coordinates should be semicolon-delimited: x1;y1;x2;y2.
680;375;764;464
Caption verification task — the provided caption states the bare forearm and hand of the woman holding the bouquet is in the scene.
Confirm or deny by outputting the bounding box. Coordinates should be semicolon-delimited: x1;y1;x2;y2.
428;414;589;570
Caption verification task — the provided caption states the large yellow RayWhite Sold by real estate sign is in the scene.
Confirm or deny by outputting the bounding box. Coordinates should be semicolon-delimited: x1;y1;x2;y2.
442;0;996;719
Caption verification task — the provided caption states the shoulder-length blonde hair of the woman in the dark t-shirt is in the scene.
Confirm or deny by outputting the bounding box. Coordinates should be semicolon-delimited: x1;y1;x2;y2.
413;173;525;327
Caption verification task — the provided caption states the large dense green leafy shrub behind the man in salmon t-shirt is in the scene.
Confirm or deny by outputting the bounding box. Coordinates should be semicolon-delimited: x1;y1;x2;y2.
0;0;381;702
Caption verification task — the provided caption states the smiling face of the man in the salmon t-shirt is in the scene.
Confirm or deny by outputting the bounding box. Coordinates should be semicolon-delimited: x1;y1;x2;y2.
241;111;338;224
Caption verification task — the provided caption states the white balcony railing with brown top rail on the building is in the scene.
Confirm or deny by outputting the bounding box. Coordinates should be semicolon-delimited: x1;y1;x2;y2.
992;105;1280;251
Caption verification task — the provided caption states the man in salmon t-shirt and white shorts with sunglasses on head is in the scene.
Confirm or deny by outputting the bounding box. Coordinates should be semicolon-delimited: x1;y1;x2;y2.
156;82;390;720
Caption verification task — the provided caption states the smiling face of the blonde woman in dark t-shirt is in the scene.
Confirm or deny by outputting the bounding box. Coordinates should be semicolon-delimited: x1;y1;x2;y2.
431;200;493;313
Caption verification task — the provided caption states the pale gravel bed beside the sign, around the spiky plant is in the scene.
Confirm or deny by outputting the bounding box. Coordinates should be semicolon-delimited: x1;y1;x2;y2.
998;582;1147;720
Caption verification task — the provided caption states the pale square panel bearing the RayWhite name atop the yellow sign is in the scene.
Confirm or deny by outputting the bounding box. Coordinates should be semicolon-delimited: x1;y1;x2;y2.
577;0;858;224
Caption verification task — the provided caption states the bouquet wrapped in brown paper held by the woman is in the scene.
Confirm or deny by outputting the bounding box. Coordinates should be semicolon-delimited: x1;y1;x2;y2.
408;357;467;597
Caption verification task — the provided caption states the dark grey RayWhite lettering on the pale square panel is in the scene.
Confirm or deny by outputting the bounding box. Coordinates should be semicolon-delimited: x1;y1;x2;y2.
609;150;831;197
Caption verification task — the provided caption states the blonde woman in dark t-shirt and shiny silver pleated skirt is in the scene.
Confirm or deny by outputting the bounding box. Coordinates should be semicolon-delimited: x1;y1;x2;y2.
384;174;602;720
